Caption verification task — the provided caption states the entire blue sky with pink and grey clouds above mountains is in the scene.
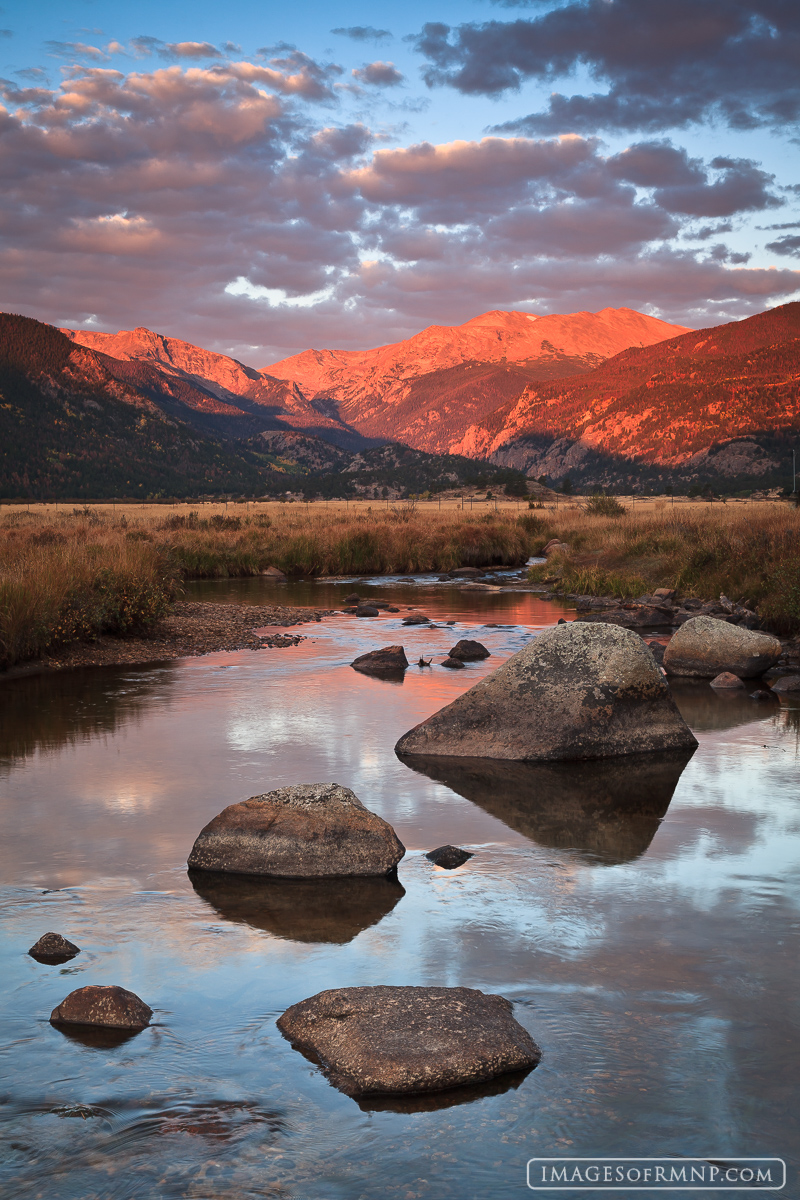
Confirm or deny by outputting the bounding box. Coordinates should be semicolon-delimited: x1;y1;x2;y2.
0;0;800;367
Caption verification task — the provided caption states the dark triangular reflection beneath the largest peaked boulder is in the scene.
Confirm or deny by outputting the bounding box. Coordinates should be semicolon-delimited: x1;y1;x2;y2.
405;750;693;864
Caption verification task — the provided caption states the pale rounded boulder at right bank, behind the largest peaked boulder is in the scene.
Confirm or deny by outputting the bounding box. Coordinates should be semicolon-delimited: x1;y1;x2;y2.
664;617;783;679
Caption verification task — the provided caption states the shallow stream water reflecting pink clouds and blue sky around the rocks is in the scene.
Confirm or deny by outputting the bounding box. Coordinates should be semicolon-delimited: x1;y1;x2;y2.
0;581;800;1200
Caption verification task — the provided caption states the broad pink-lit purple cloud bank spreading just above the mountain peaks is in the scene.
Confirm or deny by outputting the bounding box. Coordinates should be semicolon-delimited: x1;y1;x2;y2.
0;62;800;366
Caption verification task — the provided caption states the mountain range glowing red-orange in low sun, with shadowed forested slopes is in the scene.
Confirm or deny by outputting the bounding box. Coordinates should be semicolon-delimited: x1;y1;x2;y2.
0;304;800;496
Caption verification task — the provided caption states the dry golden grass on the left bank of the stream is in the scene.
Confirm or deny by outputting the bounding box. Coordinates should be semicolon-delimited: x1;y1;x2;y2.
0;504;531;666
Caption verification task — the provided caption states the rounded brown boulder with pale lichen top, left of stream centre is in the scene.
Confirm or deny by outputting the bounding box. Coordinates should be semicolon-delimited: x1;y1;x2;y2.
188;784;405;878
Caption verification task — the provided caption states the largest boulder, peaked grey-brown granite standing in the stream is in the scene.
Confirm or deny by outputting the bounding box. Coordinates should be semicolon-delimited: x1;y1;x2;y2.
395;622;697;762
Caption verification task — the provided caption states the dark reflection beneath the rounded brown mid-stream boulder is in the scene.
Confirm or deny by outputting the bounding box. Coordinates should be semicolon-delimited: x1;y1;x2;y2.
188;871;405;946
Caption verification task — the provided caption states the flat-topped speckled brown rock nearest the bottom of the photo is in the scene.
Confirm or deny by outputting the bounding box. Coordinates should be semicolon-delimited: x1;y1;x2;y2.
278;986;541;1097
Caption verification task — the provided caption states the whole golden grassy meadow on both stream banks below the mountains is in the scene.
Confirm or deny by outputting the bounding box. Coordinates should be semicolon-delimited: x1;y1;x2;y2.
0;497;800;668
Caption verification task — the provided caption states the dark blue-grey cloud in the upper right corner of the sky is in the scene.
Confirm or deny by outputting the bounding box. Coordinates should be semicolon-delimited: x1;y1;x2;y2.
415;0;800;136
